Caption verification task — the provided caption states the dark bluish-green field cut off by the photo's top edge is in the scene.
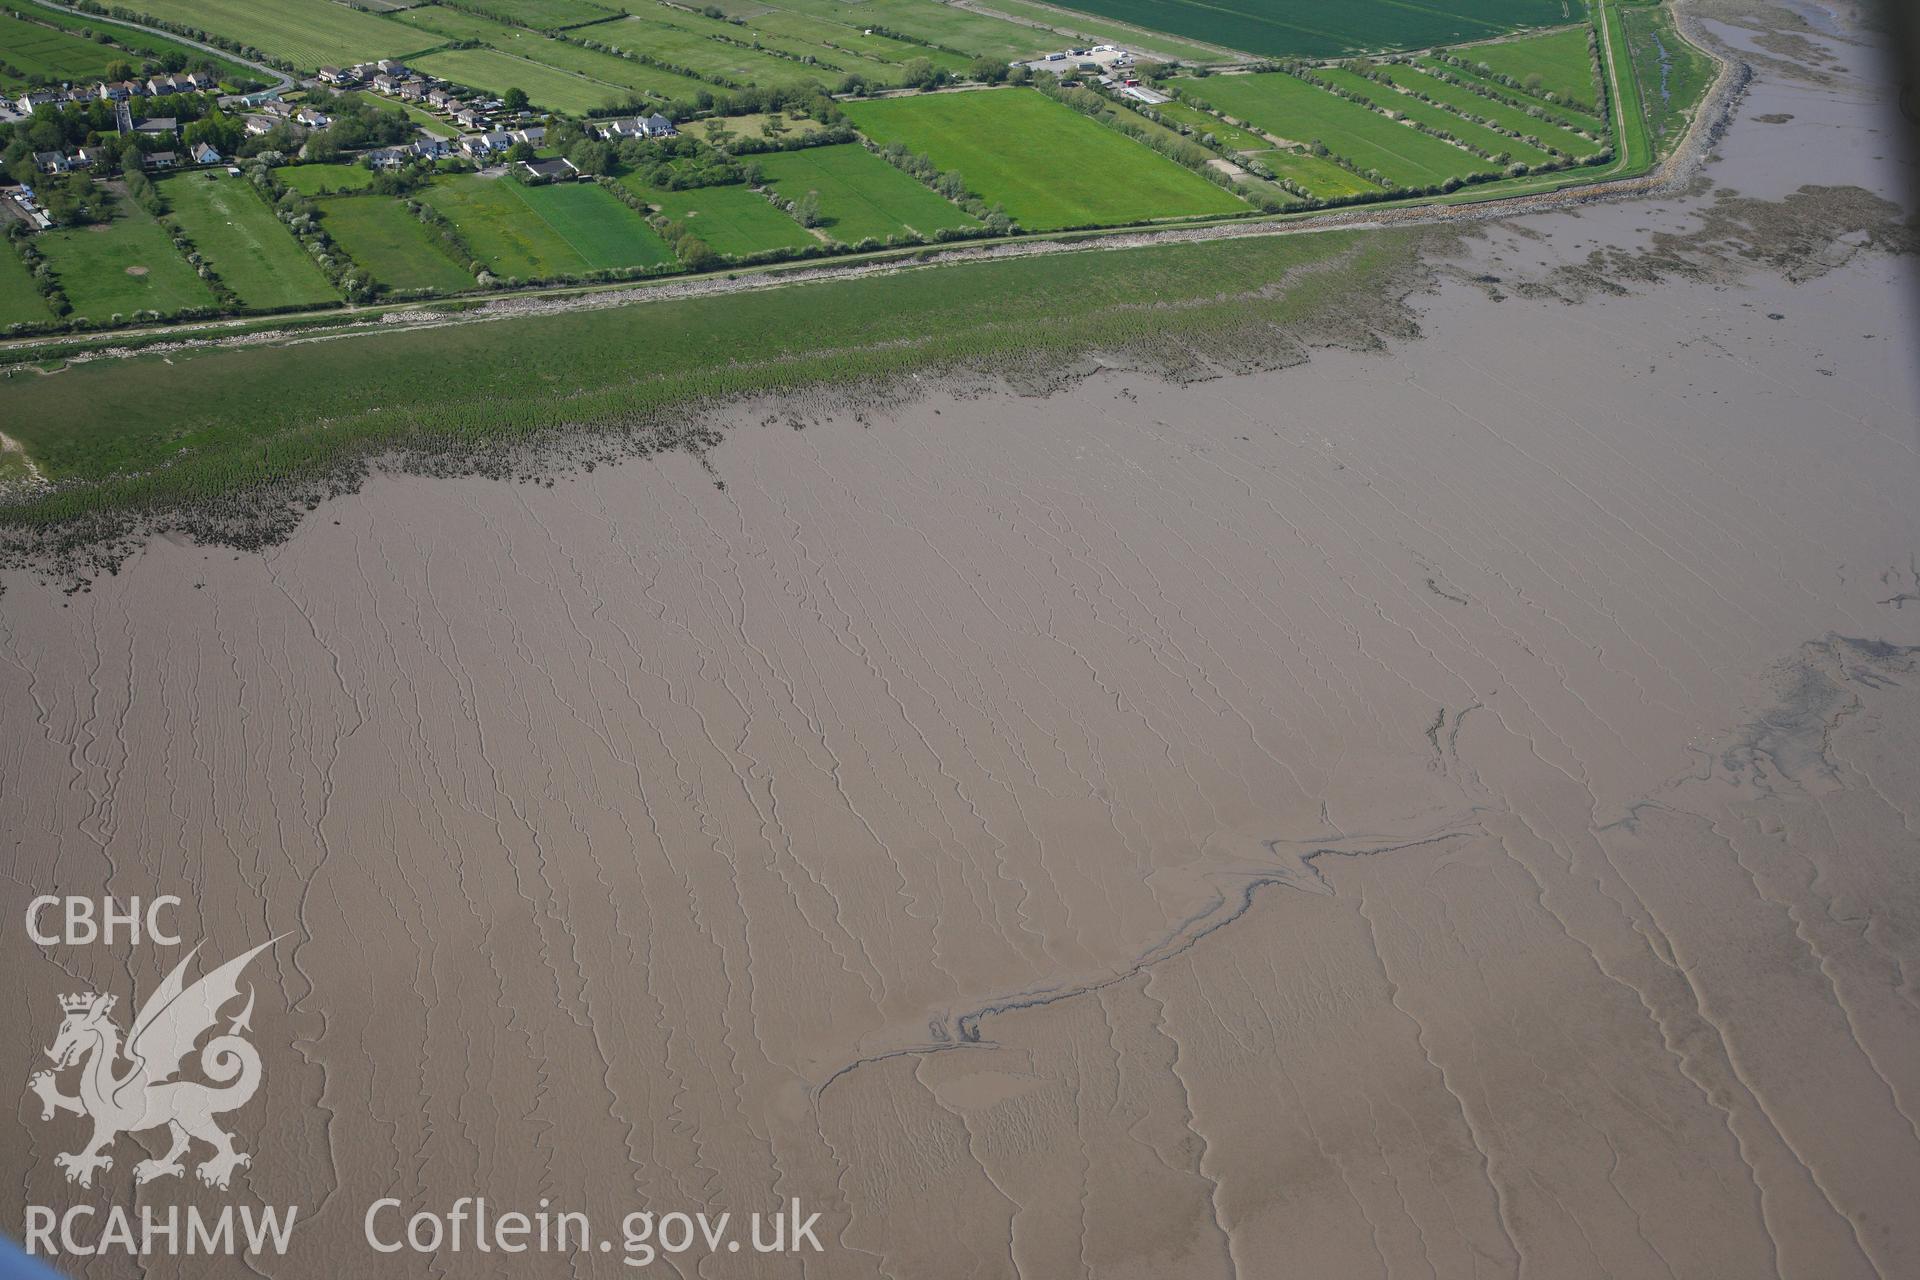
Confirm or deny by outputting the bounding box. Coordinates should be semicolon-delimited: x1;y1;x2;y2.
1036;0;1578;58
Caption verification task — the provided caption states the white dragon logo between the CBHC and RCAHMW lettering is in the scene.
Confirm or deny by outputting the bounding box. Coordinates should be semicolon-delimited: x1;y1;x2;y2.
29;938;280;1190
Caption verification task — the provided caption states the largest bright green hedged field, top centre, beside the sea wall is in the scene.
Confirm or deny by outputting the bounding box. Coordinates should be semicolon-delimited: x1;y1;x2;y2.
847;88;1248;230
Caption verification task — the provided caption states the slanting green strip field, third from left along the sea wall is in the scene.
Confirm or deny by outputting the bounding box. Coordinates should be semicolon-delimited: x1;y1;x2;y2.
159;173;340;307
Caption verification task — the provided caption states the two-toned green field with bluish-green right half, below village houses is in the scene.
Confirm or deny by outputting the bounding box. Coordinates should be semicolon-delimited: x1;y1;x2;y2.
422;175;679;278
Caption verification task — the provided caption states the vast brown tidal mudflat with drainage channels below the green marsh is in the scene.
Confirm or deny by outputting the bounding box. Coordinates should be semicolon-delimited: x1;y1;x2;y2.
0;5;1920;1280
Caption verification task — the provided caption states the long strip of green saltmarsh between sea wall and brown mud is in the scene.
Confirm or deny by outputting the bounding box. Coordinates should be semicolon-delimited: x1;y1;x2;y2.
0;228;1444;551
